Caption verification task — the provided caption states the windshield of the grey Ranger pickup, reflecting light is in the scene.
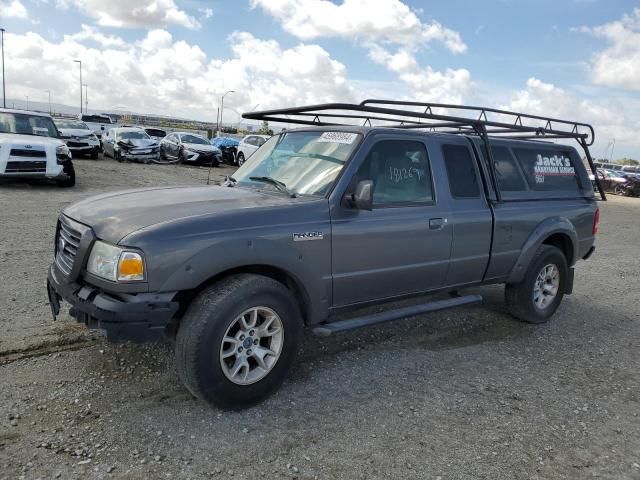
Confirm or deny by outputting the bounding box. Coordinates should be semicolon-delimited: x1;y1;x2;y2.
233;131;361;195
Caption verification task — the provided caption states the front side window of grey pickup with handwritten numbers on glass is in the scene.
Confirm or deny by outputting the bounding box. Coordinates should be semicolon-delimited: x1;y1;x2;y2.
356;140;434;208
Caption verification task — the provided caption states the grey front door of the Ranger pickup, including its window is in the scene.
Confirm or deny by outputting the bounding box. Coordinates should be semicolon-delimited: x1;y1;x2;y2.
331;140;452;307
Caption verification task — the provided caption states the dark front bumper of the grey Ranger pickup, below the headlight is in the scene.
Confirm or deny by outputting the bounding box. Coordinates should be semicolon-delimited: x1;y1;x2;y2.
47;265;179;343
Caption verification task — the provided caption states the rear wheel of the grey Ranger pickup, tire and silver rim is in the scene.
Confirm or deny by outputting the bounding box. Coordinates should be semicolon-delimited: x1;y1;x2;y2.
505;245;569;323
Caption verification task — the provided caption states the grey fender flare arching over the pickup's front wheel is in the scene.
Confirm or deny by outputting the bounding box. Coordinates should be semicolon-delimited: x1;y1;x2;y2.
160;238;331;324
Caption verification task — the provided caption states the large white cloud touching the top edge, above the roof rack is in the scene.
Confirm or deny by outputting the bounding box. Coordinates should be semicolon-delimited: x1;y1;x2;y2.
251;0;472;103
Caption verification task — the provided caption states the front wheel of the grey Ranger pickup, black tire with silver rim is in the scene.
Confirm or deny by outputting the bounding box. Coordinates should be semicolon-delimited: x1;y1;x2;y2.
176;274;302;410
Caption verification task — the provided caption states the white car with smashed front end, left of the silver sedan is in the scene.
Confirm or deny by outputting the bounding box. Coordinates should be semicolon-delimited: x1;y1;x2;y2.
103;127;159;163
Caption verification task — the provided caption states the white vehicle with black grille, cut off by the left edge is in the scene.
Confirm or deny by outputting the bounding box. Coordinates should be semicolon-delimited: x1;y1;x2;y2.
0;108;76;187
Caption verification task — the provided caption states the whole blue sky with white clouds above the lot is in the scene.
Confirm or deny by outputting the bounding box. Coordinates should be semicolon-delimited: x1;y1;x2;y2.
0;0;640;158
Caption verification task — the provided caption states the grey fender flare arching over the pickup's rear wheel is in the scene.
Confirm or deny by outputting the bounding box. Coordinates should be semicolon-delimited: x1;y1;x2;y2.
506;217;578;283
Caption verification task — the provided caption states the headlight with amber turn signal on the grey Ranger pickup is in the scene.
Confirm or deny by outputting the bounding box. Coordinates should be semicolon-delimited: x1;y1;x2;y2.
87;241;144;282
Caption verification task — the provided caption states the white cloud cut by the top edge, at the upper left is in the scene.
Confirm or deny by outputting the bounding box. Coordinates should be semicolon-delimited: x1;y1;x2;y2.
58;0;201;30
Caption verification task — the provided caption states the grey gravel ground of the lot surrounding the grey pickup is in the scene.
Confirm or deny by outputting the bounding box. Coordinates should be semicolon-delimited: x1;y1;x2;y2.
0;161;640;480
